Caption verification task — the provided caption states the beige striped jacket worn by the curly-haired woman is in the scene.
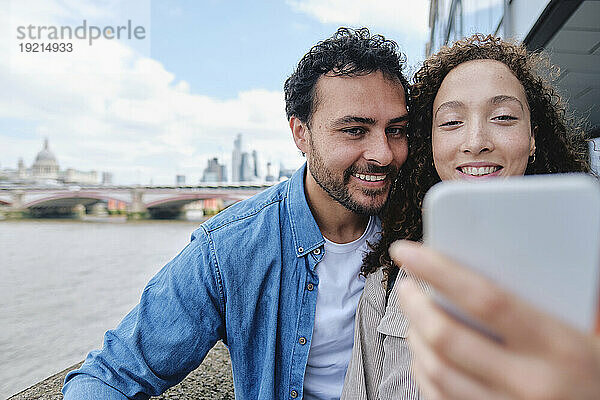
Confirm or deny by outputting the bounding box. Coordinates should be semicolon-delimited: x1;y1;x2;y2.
341;268;423;400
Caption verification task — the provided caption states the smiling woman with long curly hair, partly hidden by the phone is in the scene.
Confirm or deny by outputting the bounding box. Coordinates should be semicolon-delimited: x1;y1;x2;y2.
342;35;589;399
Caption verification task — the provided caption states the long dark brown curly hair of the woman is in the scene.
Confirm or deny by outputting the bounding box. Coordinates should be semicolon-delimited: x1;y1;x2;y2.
362;34;589;279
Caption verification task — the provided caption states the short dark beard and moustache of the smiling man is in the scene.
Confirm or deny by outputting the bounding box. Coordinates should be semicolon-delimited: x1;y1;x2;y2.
308;147;398;215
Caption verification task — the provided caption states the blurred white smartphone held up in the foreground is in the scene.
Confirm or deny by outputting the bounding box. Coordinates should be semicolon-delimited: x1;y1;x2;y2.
423;174;600;337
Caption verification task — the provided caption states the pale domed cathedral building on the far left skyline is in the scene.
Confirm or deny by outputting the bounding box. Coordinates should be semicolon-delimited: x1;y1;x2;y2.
0;139;104;185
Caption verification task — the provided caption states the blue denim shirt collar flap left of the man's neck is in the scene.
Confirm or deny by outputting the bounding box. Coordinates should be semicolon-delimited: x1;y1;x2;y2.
287;163;325;257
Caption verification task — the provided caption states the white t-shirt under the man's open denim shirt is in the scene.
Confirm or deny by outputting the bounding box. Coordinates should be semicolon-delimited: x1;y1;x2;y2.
304;217;381;400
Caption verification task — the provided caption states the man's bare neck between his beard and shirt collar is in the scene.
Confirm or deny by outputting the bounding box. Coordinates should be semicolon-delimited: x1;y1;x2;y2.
304;171;369;243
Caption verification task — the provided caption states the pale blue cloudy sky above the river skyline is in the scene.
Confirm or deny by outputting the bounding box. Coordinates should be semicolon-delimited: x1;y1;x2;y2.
0;0;429;184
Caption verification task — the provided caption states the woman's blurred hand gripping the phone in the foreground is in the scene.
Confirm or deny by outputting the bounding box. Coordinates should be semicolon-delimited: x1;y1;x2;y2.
390;241;600;400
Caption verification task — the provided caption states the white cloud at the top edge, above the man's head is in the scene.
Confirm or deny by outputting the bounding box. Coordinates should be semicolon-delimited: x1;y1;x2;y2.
287;0;429;34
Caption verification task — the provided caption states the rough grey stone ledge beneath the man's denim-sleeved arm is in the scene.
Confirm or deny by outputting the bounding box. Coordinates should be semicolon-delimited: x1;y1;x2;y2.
7;342;235;400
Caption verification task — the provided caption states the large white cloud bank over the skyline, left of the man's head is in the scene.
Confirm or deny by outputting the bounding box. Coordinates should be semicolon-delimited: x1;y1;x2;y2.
0;0;301;183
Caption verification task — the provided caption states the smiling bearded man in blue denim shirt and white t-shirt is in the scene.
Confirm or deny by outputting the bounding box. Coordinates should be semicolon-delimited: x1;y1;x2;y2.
63;28;408;400
